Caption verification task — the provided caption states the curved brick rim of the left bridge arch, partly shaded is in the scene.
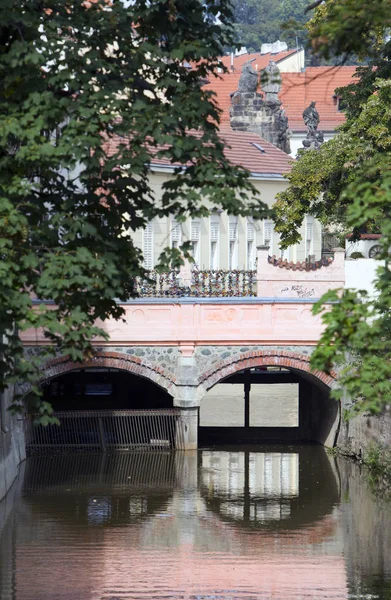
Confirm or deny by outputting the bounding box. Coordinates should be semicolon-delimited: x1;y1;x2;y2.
40;351;176;396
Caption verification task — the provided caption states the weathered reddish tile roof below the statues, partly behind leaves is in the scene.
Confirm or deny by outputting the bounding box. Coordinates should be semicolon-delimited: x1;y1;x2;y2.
105;128;294;177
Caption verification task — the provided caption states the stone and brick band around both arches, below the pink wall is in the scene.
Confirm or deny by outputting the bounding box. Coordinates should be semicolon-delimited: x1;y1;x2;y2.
34;345;336;408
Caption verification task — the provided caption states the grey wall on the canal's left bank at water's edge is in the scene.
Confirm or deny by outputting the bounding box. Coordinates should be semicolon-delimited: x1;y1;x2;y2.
0;389;26;500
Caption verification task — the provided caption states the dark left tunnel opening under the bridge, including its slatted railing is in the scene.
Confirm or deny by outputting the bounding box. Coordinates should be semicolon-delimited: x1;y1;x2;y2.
25;368;183;456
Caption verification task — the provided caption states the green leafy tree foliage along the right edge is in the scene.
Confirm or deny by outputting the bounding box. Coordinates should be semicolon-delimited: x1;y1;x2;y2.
276;0;391;414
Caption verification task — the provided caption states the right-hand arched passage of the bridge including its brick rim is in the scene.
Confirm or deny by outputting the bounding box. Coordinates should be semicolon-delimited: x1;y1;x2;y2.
199;349;340;446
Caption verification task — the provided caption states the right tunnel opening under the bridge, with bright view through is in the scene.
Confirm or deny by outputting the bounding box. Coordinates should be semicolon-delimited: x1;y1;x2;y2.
199;365;339;447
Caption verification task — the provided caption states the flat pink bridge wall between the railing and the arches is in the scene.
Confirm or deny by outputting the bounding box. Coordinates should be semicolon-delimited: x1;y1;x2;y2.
21;300;324;348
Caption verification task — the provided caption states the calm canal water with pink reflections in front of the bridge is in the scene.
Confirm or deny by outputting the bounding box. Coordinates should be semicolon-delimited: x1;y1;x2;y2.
0;446;391;600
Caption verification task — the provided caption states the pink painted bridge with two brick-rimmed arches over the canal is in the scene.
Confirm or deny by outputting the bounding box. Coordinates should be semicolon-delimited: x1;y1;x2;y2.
22;248;345;449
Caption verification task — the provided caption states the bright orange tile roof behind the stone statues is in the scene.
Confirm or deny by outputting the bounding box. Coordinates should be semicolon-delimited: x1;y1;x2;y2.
205;65;356;131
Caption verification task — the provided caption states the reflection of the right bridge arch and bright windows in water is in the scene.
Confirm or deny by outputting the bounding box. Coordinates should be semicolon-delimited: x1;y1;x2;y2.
200;447;340;529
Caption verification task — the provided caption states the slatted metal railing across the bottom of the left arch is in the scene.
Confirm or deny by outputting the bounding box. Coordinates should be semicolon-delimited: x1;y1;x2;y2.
25;408;184;456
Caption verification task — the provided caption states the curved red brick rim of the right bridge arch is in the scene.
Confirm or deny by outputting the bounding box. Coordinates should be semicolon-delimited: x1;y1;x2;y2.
199;349;337;391
